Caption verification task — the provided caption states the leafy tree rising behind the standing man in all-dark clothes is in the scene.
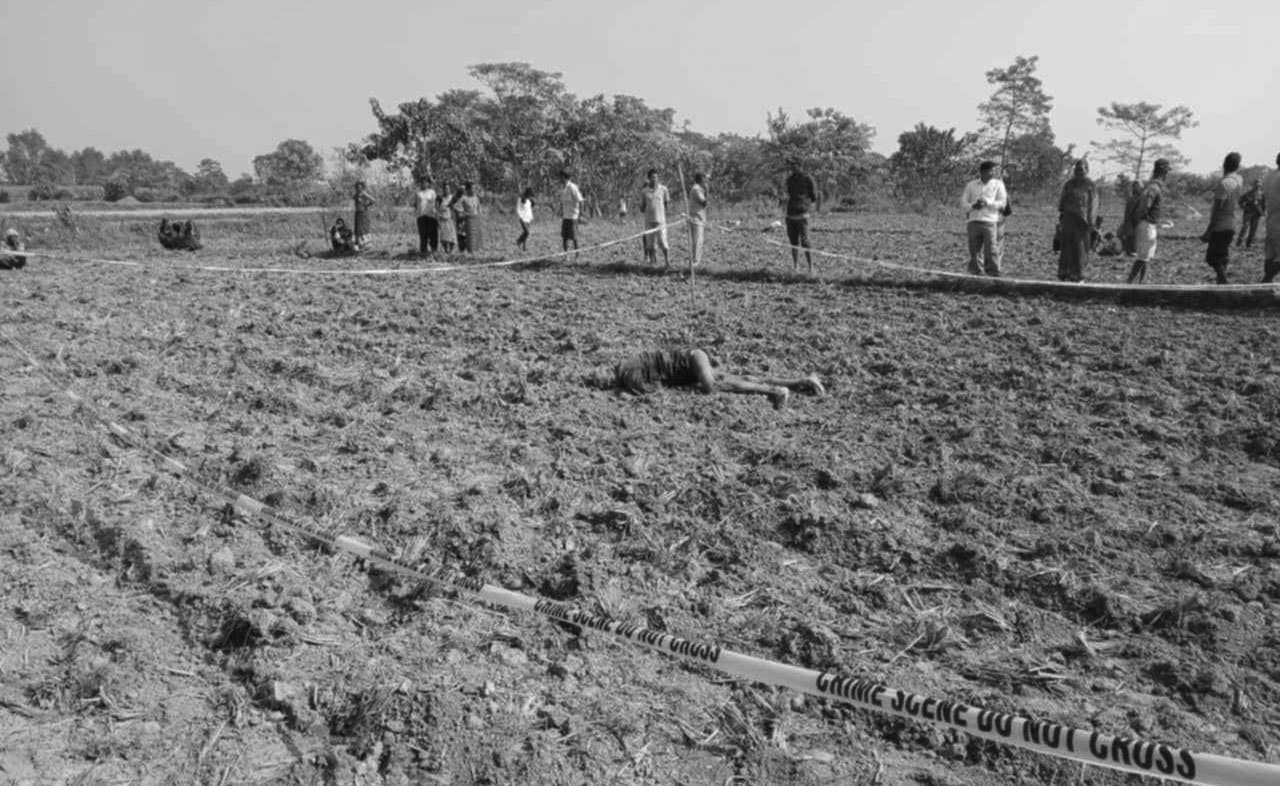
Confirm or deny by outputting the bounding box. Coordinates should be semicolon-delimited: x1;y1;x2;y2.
764;108;876;206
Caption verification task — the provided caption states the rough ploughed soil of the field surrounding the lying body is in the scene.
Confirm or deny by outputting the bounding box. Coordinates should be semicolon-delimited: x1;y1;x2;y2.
0;206;1280;786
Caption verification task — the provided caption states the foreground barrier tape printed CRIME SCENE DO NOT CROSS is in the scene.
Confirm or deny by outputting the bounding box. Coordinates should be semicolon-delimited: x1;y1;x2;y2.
4;332;1280;786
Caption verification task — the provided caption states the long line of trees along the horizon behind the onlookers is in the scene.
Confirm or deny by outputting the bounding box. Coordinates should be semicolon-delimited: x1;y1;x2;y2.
0;56;1239;206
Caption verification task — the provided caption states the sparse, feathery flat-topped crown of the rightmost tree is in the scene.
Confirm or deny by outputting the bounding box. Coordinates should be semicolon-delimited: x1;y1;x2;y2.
1093;101;1199;179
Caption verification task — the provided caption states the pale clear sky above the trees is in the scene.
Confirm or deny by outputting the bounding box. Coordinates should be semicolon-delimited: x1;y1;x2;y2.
0;0;1280;178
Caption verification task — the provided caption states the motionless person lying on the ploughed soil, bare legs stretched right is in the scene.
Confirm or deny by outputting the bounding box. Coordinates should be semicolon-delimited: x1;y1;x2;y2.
588;349;827;408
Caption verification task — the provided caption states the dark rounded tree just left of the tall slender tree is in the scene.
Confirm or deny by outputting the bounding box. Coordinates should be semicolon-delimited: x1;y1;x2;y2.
888;123;978;202
